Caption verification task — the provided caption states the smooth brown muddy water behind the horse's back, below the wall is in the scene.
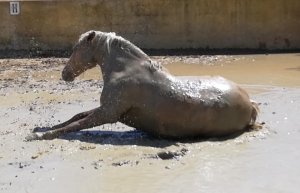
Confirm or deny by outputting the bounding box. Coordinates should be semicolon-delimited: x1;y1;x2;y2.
165;54;300;87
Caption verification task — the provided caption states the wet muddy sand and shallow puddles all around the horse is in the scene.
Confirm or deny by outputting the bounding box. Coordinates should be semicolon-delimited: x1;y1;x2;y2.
0;54;300;193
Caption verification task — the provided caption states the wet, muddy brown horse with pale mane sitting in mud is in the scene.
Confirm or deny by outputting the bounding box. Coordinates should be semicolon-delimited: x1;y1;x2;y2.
26;30;259;141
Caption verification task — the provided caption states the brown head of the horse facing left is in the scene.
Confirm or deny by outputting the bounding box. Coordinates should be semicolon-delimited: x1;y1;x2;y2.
62;31;97;81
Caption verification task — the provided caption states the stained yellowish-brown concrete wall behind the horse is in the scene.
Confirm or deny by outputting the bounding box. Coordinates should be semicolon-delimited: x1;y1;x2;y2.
0;0;300;50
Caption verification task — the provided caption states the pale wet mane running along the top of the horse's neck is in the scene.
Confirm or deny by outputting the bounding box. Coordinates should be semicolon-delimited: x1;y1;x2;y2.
79;31;166;70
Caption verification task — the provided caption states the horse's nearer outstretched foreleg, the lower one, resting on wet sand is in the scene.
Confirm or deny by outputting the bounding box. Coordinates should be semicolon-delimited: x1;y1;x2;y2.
25;107;119;141
